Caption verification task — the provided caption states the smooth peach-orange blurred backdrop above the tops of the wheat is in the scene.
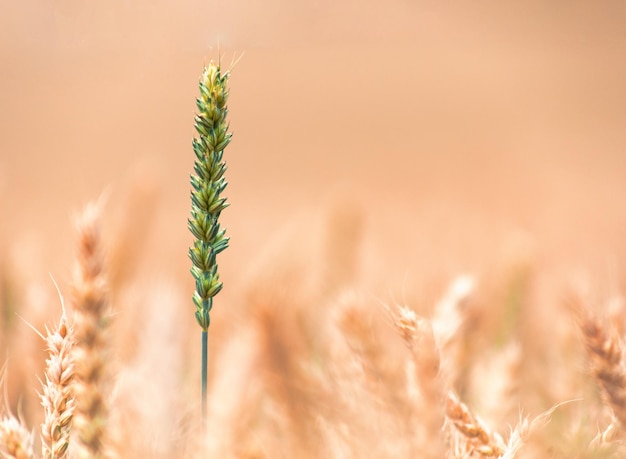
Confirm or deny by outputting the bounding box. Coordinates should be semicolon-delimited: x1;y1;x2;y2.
0;0;626;374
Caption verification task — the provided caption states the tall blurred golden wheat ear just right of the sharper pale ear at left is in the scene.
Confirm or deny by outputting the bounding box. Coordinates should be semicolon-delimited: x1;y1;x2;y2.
72;204;109;459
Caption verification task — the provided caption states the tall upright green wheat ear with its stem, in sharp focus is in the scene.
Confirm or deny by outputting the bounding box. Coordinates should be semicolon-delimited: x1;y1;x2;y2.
188;62;231;426
